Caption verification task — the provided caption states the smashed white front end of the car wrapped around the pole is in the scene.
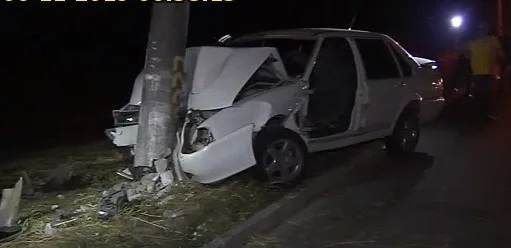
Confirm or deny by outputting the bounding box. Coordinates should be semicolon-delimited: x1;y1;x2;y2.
107;47;303;184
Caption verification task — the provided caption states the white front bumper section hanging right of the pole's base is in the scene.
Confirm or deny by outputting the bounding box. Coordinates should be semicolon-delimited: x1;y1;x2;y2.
178;125;256;184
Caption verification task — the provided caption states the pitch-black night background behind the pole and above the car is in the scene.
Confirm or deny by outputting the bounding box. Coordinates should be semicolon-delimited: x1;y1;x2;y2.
0;0;493;153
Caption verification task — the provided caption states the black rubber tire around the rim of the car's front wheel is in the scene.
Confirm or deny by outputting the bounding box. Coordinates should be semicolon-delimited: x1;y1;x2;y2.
253;126;307;186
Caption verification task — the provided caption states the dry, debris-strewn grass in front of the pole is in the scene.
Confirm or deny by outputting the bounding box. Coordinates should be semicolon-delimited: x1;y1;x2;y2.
0;142;285;248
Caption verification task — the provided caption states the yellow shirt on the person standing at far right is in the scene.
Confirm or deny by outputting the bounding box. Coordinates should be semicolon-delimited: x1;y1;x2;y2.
468;36;501;75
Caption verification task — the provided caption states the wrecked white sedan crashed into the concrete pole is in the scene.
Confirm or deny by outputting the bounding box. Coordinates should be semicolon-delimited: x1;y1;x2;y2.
107;29;443;184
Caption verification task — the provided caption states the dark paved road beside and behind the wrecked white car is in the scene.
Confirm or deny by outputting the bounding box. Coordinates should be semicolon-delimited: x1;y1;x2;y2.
250;99;511;248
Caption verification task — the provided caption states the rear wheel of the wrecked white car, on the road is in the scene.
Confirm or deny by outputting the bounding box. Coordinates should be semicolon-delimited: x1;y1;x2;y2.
385;111;420;156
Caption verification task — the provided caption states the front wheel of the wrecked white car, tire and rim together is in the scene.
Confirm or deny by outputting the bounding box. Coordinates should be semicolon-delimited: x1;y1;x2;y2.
254;127;307;185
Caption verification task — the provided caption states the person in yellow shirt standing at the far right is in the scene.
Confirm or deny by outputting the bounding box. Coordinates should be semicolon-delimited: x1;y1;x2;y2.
467;23;502;120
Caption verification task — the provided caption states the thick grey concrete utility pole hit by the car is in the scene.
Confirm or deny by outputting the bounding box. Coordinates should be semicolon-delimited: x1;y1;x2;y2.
134;2;190;178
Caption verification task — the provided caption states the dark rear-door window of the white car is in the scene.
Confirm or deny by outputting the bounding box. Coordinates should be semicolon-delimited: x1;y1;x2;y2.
355;39;401;80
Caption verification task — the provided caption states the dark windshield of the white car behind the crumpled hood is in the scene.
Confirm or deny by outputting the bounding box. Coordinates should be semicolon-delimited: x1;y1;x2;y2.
229;38;315;78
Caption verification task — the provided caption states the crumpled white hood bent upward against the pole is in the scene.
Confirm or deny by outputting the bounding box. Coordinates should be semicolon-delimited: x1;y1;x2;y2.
184;46;286;110
